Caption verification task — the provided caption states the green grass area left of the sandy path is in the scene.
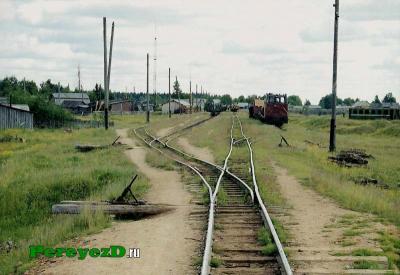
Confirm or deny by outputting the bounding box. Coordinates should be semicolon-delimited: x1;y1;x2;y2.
0;113;148;274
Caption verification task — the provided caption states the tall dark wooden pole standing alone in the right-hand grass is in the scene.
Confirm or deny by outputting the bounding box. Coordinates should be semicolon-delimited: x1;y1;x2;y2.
329;0;339;152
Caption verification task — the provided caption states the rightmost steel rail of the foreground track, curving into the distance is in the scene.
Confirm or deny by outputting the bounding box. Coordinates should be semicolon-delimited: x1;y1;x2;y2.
235;115;293;275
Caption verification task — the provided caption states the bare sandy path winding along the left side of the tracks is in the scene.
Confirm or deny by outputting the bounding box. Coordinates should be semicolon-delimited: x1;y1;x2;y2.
40;129;197;274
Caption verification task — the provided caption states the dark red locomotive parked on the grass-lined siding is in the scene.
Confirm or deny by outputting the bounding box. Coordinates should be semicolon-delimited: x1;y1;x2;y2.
249;93;288;127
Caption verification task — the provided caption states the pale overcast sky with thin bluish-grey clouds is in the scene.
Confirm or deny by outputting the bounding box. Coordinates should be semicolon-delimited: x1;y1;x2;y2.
0;0;400;103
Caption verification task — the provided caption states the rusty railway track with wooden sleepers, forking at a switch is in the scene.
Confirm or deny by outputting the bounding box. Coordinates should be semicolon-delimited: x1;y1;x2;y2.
135;116;291;275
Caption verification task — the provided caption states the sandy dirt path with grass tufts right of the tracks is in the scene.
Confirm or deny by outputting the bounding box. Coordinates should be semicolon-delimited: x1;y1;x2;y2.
273;164;390;274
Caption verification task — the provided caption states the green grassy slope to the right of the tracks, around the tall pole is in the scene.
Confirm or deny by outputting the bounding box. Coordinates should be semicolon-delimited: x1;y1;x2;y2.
241;113;400;266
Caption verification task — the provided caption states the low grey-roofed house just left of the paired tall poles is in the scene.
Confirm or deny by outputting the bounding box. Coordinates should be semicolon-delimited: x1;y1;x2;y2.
51;93;90;114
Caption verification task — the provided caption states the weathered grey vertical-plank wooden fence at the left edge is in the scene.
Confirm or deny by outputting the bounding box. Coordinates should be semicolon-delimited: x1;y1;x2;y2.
0;104;33;129
